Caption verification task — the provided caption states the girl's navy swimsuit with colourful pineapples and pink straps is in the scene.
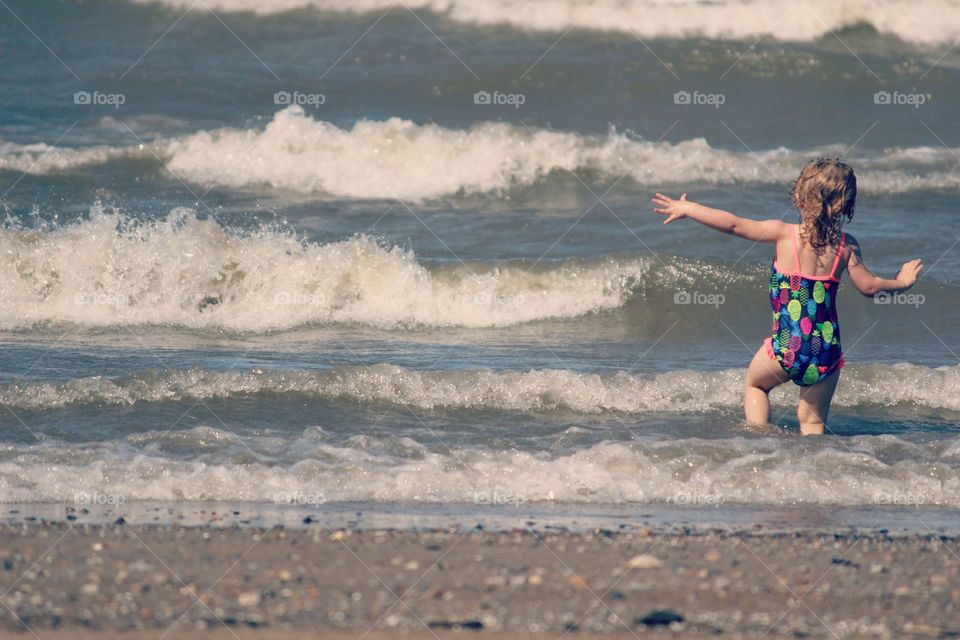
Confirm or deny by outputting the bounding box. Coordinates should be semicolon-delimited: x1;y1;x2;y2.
764;227;846;387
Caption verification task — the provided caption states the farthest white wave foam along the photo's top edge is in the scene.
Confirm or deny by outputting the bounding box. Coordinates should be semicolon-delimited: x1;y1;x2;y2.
125;0;960;45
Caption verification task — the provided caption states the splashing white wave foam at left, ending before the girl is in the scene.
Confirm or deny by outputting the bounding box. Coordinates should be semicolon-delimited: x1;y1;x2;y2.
0;207;652;332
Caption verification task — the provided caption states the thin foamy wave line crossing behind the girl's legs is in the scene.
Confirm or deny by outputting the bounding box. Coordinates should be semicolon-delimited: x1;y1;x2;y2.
7;364;960;414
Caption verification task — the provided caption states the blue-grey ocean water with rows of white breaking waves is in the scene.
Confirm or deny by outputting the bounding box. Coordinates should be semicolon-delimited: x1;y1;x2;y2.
0;0;960;522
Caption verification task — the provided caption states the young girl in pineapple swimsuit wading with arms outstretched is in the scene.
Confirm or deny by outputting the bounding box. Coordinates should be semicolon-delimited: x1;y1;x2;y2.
653;158;923;435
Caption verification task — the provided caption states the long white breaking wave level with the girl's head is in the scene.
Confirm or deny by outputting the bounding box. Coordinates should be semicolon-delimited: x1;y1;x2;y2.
0;106;960;201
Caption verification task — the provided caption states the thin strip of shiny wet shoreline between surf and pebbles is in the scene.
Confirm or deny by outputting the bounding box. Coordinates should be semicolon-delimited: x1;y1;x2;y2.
0;501;960;536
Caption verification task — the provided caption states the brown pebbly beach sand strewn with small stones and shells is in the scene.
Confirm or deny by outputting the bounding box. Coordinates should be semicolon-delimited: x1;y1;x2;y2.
0;522;960;640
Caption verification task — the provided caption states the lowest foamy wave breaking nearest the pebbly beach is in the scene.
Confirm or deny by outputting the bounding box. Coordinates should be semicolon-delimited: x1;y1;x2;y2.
0;427;960;507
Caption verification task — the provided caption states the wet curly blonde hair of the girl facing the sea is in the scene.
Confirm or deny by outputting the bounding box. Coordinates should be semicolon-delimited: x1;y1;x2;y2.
790;158;857;252
